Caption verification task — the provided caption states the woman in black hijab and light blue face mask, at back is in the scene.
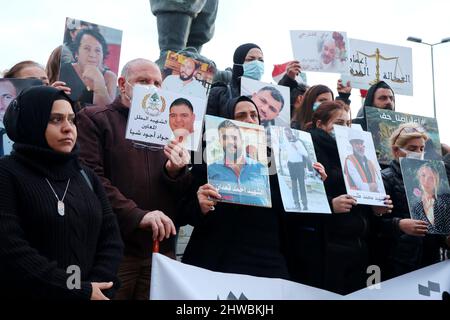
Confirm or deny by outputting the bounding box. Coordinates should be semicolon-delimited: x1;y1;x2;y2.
206;43;264;115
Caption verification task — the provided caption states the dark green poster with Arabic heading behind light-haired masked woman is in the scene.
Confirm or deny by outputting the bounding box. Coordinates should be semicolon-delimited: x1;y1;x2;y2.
365;107;442;165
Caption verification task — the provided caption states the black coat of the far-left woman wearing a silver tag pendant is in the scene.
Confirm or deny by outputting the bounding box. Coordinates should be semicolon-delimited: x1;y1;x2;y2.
0;144;123;300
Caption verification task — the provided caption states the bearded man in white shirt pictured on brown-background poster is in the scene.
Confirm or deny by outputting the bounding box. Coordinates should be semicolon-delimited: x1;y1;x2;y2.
162;57;206;98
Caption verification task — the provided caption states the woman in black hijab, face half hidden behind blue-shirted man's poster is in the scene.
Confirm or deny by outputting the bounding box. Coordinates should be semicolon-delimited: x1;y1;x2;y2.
177;96;289;279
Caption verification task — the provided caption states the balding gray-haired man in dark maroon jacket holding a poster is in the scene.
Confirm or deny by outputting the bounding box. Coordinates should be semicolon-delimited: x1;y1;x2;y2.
77;59;188;300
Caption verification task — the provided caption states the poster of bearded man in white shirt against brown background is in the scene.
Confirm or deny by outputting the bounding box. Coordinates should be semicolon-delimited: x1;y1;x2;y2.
162;51;215;99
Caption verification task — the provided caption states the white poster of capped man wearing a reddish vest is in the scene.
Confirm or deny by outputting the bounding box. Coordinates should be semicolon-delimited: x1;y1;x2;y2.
334;125;386;206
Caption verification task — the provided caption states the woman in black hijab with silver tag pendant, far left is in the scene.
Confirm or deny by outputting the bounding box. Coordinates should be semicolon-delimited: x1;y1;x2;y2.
0;86;123;300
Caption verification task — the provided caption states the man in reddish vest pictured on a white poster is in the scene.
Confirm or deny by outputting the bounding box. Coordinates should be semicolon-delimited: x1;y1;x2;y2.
344;132;383;192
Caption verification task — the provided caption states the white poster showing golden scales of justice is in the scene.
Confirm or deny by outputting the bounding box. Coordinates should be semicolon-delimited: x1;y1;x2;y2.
342;39;413;96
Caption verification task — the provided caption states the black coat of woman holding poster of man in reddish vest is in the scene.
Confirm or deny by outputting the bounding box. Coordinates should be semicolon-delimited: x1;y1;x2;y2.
288;129;370;294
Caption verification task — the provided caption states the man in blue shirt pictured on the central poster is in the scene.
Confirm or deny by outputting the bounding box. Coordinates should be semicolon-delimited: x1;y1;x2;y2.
208;120;269;206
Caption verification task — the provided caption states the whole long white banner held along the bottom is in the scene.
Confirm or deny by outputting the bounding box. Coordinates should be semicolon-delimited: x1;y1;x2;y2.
150;253;450;300
